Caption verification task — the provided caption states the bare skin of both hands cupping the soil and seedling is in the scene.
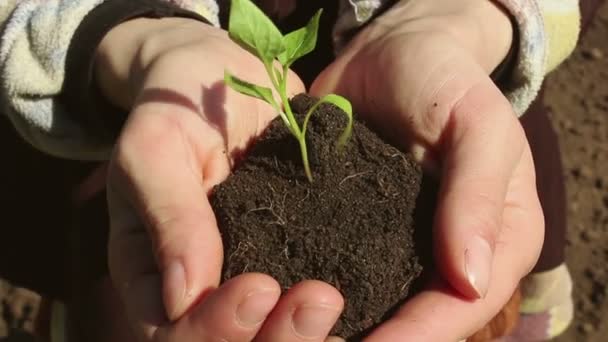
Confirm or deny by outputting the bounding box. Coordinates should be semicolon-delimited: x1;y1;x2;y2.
96;0;543;342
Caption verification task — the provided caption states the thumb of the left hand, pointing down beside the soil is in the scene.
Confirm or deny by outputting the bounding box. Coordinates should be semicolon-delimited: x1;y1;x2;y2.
109;106;222;320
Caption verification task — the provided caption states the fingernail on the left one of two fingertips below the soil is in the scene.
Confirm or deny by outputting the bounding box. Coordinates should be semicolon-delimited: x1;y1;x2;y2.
236;289;281;328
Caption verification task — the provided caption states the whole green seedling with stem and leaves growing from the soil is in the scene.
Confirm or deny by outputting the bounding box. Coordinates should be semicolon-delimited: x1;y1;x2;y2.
224;0;353;182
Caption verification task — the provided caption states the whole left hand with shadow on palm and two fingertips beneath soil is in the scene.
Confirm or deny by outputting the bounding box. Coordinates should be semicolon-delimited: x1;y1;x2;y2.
97;19;343;342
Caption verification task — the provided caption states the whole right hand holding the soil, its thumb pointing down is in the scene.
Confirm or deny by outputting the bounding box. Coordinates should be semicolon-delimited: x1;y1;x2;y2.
312;0;544;341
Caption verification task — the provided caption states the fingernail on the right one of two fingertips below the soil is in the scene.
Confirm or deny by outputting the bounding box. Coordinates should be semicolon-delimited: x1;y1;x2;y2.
291;305;341;338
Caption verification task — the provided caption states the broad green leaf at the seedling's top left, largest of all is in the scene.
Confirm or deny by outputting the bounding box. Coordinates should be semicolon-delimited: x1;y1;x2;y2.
228;0;285;64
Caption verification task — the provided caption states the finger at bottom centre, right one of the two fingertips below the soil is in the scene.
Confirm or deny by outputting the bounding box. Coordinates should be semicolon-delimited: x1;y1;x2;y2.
257;280;344;342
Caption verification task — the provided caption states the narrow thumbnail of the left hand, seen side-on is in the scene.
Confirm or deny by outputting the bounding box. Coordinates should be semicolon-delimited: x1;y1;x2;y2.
163;261;186;320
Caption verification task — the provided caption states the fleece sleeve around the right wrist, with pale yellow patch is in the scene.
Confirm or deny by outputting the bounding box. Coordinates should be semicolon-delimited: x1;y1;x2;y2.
334;0;580;116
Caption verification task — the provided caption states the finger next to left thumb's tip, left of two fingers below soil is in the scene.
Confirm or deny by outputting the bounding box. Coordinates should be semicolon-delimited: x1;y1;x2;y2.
155;273;281;342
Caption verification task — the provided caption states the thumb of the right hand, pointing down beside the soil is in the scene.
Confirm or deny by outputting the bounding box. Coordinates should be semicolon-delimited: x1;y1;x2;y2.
434;77;525;298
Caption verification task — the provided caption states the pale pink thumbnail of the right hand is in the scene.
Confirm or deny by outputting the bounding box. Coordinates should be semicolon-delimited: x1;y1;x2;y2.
464;236;492;298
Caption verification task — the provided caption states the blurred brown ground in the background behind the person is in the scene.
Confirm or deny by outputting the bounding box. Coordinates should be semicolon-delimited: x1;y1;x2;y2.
0;3;608;342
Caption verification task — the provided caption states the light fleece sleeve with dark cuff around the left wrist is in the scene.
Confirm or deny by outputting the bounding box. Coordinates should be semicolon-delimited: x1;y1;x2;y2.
0;0;218;160
